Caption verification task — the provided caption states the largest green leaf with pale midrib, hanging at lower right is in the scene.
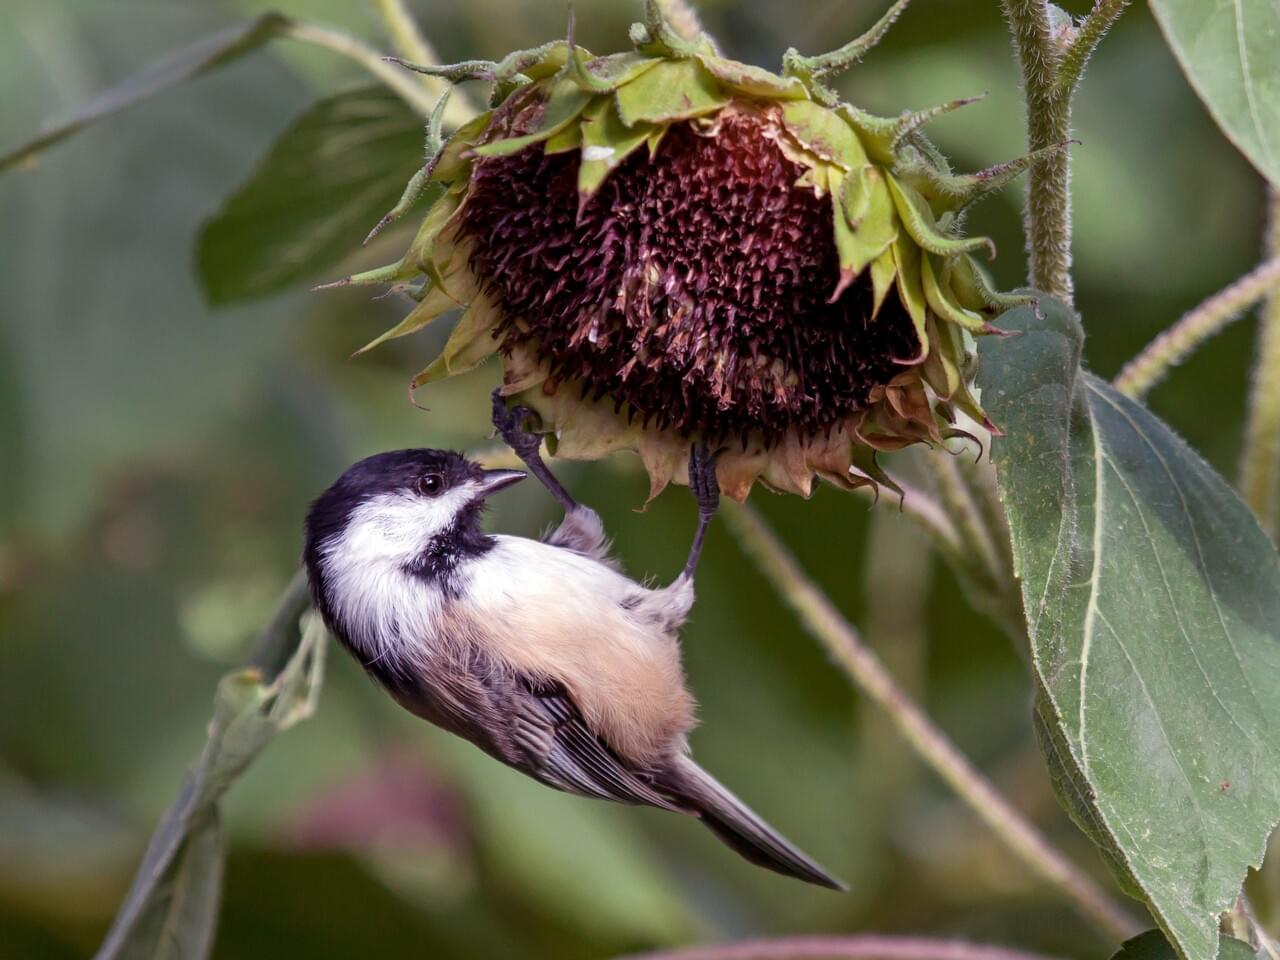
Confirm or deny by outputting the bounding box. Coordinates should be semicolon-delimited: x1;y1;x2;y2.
980;298;1280;960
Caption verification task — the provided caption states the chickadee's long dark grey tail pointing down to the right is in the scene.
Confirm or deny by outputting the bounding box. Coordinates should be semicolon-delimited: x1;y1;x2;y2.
672;756;847;890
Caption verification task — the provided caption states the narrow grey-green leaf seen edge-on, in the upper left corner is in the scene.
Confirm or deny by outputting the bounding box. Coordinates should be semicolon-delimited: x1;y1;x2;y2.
0;13;289;172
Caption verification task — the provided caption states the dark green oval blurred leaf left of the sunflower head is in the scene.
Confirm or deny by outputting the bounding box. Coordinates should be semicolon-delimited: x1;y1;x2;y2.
196;86;424;305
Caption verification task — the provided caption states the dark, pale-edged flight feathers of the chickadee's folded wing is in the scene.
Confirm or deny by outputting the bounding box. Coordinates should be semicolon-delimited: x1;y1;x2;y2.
511;680;689;813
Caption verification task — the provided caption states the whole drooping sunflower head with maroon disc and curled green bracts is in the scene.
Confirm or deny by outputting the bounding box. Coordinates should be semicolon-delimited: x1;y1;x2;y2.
337;4;1034;499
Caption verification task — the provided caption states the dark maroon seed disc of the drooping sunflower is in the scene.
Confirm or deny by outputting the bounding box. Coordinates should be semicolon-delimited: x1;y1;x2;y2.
461;111;919;442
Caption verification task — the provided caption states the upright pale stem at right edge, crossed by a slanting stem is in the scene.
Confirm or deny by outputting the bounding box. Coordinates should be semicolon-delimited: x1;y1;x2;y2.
1240;187;1280;540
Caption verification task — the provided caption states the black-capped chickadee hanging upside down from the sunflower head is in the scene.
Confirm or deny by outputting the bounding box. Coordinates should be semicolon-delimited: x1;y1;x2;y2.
303;393;844;890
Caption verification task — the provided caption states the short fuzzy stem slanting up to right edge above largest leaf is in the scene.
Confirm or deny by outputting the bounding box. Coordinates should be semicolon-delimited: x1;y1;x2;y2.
1112;256;1280;397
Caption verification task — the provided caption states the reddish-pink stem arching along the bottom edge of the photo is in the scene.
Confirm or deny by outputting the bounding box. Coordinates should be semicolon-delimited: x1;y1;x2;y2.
618;934;1050;960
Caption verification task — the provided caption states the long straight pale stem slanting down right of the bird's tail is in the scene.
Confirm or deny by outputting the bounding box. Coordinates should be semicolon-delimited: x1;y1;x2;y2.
722;503;1139;938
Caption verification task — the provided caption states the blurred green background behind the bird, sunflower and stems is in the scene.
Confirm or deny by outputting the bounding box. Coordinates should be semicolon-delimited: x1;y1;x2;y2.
0;0;1262;960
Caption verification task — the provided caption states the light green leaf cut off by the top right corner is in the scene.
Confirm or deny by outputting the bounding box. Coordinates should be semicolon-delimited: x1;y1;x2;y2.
1151;0;1280;184
